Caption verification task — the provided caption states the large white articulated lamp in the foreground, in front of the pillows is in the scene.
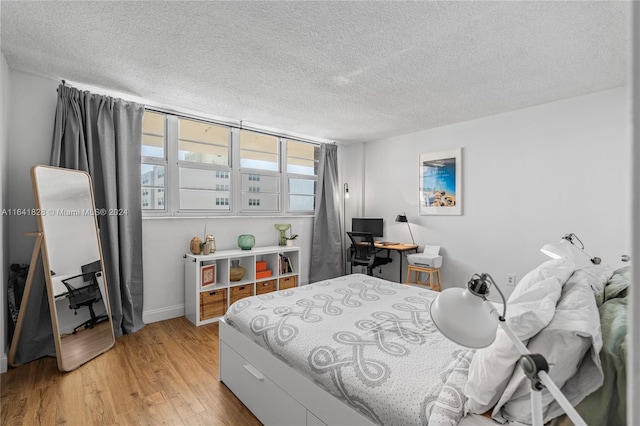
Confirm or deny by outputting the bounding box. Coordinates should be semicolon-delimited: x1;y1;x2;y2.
429;273;587;426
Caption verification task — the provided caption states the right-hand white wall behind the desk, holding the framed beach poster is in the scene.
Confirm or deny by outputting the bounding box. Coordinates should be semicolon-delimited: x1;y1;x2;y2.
364;87;631;293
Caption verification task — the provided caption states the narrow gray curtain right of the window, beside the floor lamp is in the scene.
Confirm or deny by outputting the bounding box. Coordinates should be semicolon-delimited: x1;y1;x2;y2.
309;144;344;282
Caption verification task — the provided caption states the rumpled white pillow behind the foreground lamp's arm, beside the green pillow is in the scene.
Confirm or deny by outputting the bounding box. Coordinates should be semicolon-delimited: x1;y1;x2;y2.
493;268;604;423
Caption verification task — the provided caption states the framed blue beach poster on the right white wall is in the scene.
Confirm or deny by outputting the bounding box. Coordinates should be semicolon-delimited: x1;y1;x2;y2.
419;148;462;215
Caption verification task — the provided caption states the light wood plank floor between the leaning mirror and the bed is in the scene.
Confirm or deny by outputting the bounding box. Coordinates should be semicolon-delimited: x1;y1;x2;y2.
0;318;260;426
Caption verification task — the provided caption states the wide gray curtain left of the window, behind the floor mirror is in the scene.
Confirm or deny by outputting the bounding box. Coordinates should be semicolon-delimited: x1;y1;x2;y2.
50;84;144;337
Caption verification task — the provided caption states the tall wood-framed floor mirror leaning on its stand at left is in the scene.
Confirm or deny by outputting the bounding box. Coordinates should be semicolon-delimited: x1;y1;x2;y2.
9;165;115;371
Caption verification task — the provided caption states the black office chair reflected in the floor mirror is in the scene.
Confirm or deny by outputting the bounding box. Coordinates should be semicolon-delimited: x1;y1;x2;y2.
62;272;109;334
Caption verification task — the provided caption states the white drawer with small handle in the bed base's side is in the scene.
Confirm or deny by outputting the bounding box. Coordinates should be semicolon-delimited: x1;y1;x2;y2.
220;341;307;426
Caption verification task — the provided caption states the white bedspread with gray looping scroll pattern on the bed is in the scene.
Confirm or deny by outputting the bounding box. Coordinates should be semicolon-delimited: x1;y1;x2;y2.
225;274;473;425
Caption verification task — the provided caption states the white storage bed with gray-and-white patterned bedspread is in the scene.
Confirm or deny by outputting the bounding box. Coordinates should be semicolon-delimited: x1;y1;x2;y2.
220;262;624;426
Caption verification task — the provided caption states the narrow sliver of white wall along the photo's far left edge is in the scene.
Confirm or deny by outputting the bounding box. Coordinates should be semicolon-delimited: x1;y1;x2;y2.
0;54;9;373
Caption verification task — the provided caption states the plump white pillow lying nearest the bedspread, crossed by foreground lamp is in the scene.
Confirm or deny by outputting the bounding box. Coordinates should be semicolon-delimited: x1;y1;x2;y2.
465;258;575;414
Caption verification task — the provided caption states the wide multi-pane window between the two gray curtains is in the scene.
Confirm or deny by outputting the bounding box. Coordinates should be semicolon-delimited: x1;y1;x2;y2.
141;110;320;215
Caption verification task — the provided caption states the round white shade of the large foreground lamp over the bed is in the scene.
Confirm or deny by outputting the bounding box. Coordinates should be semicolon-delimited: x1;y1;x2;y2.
430;288;498;349
